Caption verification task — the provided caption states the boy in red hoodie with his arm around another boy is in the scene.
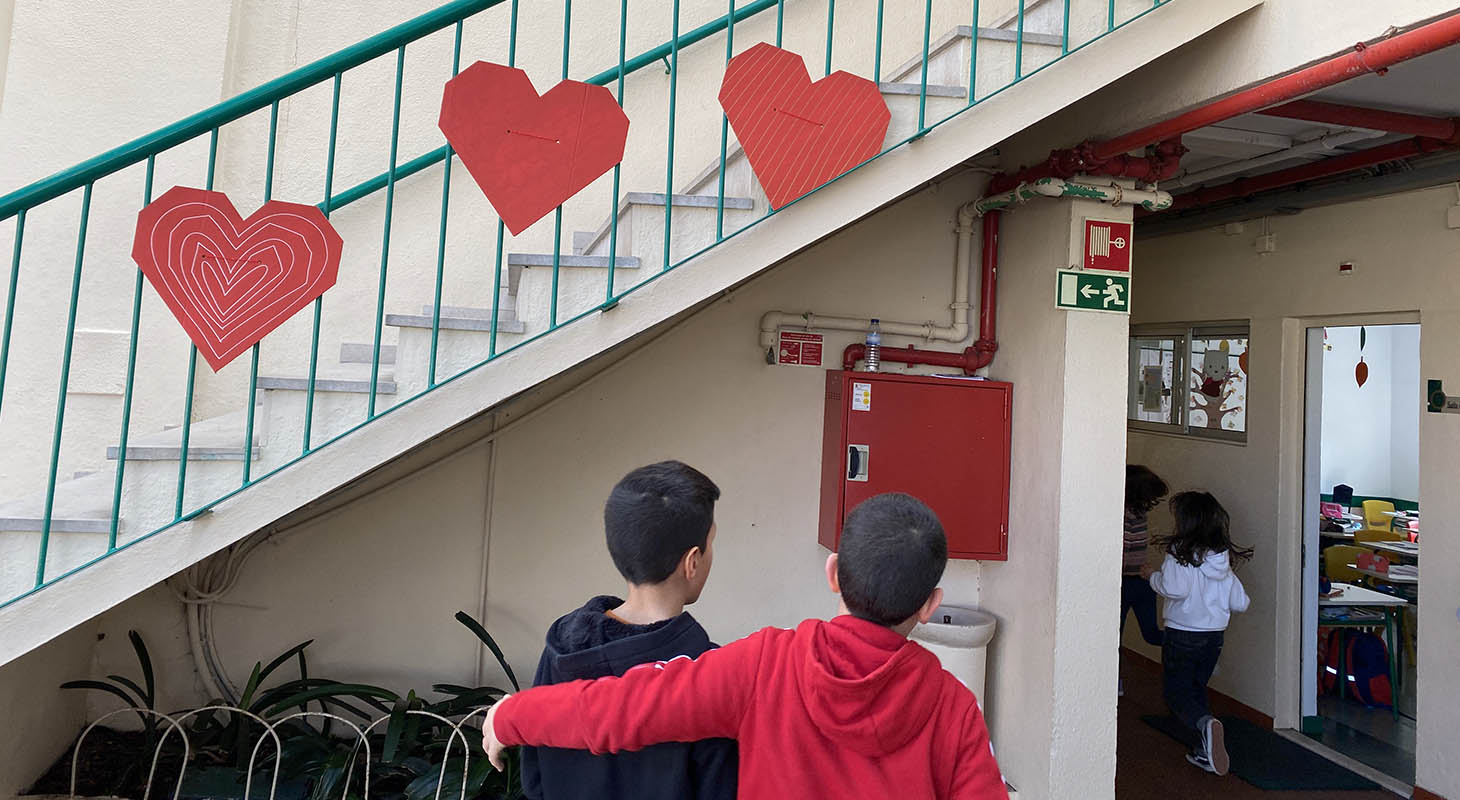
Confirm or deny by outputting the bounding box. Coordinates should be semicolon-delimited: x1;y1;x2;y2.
482;493;1007;800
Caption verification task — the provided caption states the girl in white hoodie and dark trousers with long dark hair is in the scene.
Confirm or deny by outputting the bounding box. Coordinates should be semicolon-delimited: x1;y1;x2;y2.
1150;492;1253;775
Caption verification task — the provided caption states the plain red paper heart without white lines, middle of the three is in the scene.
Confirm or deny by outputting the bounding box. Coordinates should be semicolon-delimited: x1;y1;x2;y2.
439;61;629;235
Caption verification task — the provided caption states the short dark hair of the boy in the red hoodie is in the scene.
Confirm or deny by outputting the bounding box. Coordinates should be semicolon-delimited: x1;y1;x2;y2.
837;493;948;626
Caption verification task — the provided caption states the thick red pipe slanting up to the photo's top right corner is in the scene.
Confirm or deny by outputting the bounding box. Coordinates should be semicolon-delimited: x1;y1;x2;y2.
1092;15;1460;159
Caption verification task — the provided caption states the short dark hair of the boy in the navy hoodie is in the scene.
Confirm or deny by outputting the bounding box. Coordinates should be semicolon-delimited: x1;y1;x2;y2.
603;461;720;584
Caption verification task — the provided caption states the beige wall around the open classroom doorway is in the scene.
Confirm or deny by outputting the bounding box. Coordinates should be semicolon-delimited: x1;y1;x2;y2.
1127;185;1460;797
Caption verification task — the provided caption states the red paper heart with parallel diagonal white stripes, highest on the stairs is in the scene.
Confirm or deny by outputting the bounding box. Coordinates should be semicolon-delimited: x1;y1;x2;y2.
720;42;892;209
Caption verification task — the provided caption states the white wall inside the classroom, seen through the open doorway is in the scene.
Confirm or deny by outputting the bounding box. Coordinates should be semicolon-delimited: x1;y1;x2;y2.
1318;326;1424;501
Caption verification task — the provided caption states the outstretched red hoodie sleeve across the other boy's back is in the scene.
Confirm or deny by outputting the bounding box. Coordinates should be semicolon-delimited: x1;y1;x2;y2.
491;629;778;755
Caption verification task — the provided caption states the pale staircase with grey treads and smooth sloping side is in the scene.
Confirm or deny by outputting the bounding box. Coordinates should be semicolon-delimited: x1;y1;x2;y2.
0;0;1256;663
